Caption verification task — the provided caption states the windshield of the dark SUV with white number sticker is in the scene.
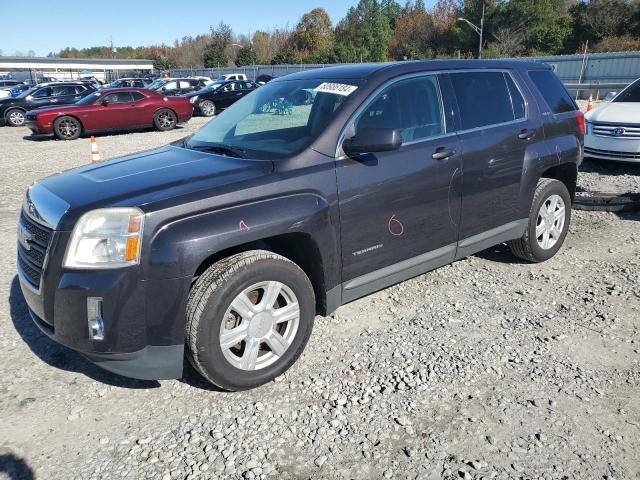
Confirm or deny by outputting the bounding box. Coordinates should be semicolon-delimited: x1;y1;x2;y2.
186;79;361;160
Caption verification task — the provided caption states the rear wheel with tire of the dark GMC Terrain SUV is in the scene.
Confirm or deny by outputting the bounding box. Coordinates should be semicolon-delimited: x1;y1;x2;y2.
509;178;571;262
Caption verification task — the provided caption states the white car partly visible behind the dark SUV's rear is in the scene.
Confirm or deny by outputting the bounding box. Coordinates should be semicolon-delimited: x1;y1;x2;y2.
584;79;640;163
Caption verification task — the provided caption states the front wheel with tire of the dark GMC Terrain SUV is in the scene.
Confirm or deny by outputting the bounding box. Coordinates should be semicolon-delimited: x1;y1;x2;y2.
186;250;315;390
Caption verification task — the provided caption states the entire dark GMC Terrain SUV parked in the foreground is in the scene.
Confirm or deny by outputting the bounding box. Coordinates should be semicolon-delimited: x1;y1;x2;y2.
17;60;585;390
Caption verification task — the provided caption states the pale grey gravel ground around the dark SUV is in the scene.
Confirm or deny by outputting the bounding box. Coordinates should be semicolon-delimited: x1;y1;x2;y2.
0;118;640;480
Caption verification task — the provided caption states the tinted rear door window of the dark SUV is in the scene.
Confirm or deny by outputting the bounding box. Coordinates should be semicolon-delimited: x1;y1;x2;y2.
450;72;515;130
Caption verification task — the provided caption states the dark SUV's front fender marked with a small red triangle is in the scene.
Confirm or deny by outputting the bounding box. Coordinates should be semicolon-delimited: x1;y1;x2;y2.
147;194;338;284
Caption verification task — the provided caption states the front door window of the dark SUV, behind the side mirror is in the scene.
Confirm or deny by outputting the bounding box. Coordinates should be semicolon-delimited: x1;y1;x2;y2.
354;75;444;143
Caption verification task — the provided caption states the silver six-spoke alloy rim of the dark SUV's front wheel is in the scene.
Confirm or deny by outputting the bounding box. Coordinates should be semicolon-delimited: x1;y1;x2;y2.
220;281;300;370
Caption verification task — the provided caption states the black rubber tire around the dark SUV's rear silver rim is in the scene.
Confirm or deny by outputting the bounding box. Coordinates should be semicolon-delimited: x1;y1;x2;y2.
508;178;571;263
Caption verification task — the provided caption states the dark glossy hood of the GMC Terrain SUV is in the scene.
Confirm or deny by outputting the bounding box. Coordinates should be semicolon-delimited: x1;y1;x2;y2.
39;145;273;230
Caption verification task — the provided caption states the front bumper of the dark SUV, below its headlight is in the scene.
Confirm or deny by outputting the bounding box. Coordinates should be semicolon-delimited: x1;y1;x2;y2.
18;244;190;380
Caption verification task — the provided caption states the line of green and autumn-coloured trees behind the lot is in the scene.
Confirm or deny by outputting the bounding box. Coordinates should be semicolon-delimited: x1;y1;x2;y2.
50;0;640;70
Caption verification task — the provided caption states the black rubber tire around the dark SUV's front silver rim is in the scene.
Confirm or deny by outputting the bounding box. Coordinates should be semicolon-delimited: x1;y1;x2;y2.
185;250;315;391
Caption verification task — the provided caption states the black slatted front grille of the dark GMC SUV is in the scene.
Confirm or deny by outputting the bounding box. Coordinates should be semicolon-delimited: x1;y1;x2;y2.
18;212;53;288
